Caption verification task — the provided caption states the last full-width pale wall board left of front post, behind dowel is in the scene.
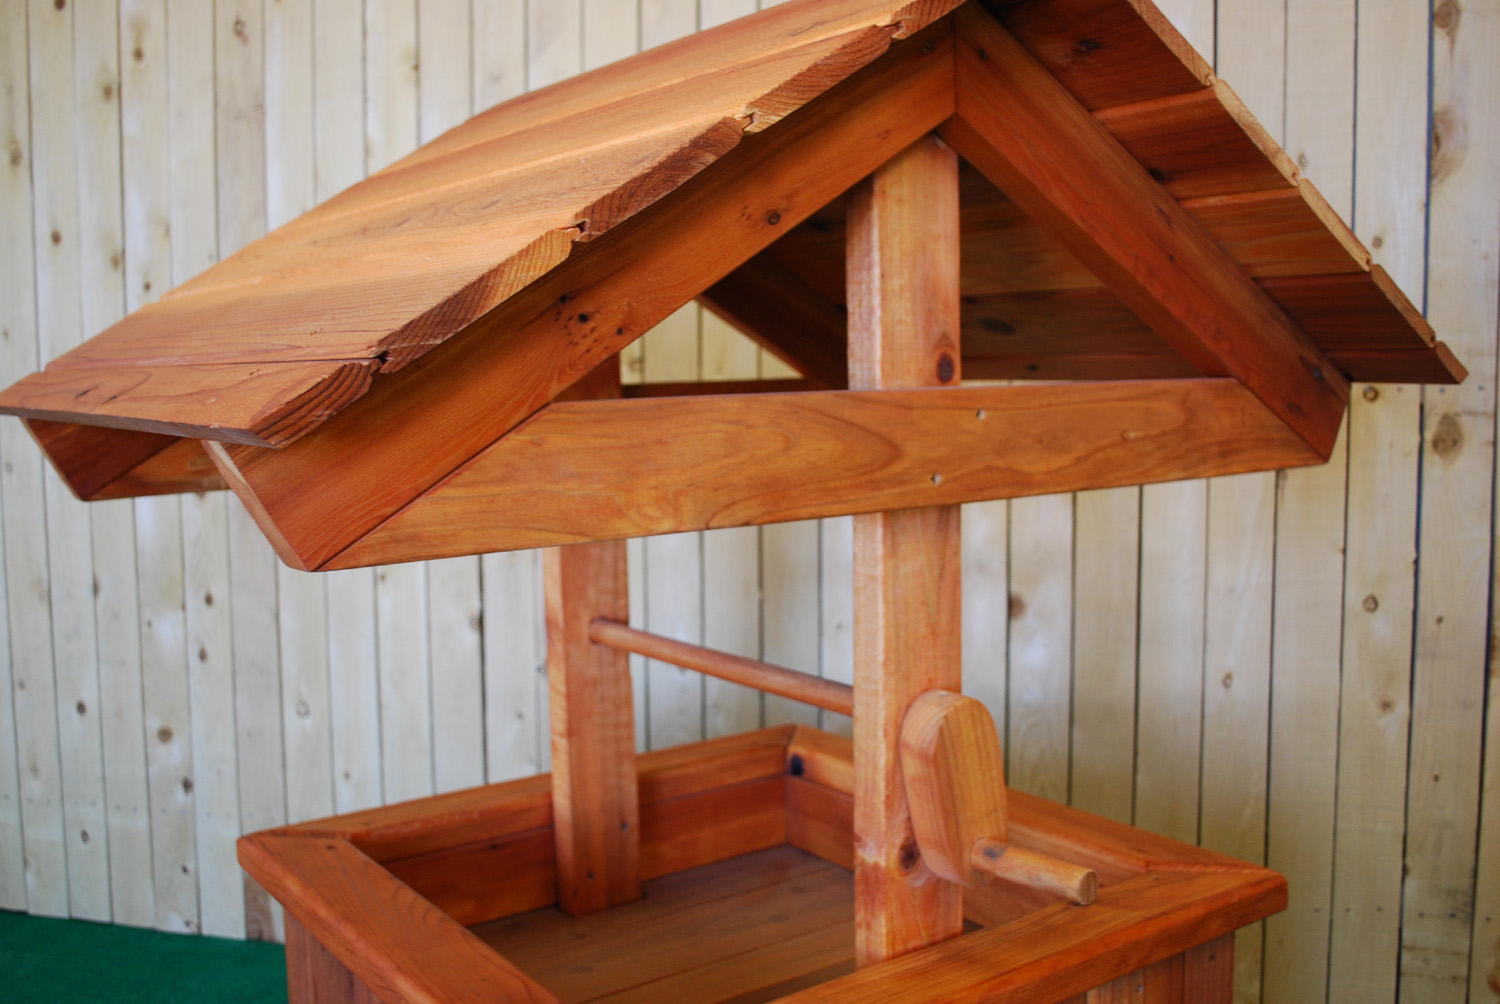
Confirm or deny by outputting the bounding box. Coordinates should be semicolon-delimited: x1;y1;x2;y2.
761;519;819;725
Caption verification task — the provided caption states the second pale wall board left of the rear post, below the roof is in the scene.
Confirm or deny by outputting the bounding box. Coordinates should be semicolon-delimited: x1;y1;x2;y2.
428;558;485;791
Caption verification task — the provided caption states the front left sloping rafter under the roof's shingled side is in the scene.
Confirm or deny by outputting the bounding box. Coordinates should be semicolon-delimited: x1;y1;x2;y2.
215;26;953;567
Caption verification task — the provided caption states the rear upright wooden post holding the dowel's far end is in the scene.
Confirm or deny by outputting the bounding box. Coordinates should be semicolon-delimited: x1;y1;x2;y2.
542;360;641;917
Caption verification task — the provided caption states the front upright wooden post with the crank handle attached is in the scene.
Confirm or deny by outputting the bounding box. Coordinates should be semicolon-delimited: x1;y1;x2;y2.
848;137;963;965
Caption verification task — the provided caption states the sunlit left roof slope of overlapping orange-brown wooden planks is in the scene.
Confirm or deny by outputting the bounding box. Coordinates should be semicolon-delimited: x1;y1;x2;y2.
0;0;951;443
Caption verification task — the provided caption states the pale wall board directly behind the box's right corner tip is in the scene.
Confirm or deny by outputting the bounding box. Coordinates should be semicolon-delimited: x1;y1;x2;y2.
1199;7;1287;1004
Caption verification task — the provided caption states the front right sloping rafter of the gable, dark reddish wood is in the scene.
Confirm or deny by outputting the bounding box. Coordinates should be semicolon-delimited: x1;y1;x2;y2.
944;8;1349;452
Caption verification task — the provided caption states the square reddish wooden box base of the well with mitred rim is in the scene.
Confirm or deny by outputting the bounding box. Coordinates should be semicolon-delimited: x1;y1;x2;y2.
240;726;1286;1004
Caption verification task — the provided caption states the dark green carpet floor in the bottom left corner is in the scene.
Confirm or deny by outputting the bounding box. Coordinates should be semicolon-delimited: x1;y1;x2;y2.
0;911;287;1004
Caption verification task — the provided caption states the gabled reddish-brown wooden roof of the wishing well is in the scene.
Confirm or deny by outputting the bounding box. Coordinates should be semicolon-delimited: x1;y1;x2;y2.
0;0;1463;567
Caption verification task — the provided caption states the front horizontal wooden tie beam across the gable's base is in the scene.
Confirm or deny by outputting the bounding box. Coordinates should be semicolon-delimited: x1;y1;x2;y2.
327;380;1320;567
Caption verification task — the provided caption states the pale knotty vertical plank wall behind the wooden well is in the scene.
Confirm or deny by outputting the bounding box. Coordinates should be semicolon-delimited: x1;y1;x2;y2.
0;0;1500;1004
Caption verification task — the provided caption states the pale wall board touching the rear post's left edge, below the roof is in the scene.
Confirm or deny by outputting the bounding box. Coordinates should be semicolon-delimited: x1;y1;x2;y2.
482;551;548;782
